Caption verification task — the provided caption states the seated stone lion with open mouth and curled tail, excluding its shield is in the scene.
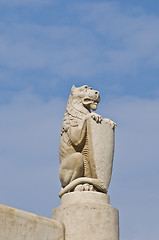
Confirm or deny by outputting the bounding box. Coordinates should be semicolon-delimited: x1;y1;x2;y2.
59;85;116;197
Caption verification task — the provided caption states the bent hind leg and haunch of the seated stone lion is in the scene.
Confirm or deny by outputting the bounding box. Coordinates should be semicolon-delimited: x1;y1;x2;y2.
59;152;84;188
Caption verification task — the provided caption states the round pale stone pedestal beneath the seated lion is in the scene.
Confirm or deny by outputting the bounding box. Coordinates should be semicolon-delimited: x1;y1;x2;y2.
53;191;119;240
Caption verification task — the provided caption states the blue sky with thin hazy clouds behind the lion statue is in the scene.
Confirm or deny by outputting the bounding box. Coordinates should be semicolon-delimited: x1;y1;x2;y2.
0;0;159;240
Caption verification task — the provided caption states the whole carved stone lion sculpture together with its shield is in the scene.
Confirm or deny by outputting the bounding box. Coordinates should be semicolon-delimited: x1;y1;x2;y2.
59;85;116;197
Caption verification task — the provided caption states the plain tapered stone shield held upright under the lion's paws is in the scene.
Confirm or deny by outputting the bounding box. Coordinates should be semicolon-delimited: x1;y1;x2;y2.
87;117;114;189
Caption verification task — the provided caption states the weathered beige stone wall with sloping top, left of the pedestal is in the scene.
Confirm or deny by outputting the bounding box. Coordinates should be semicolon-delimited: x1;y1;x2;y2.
0;205;64;240
